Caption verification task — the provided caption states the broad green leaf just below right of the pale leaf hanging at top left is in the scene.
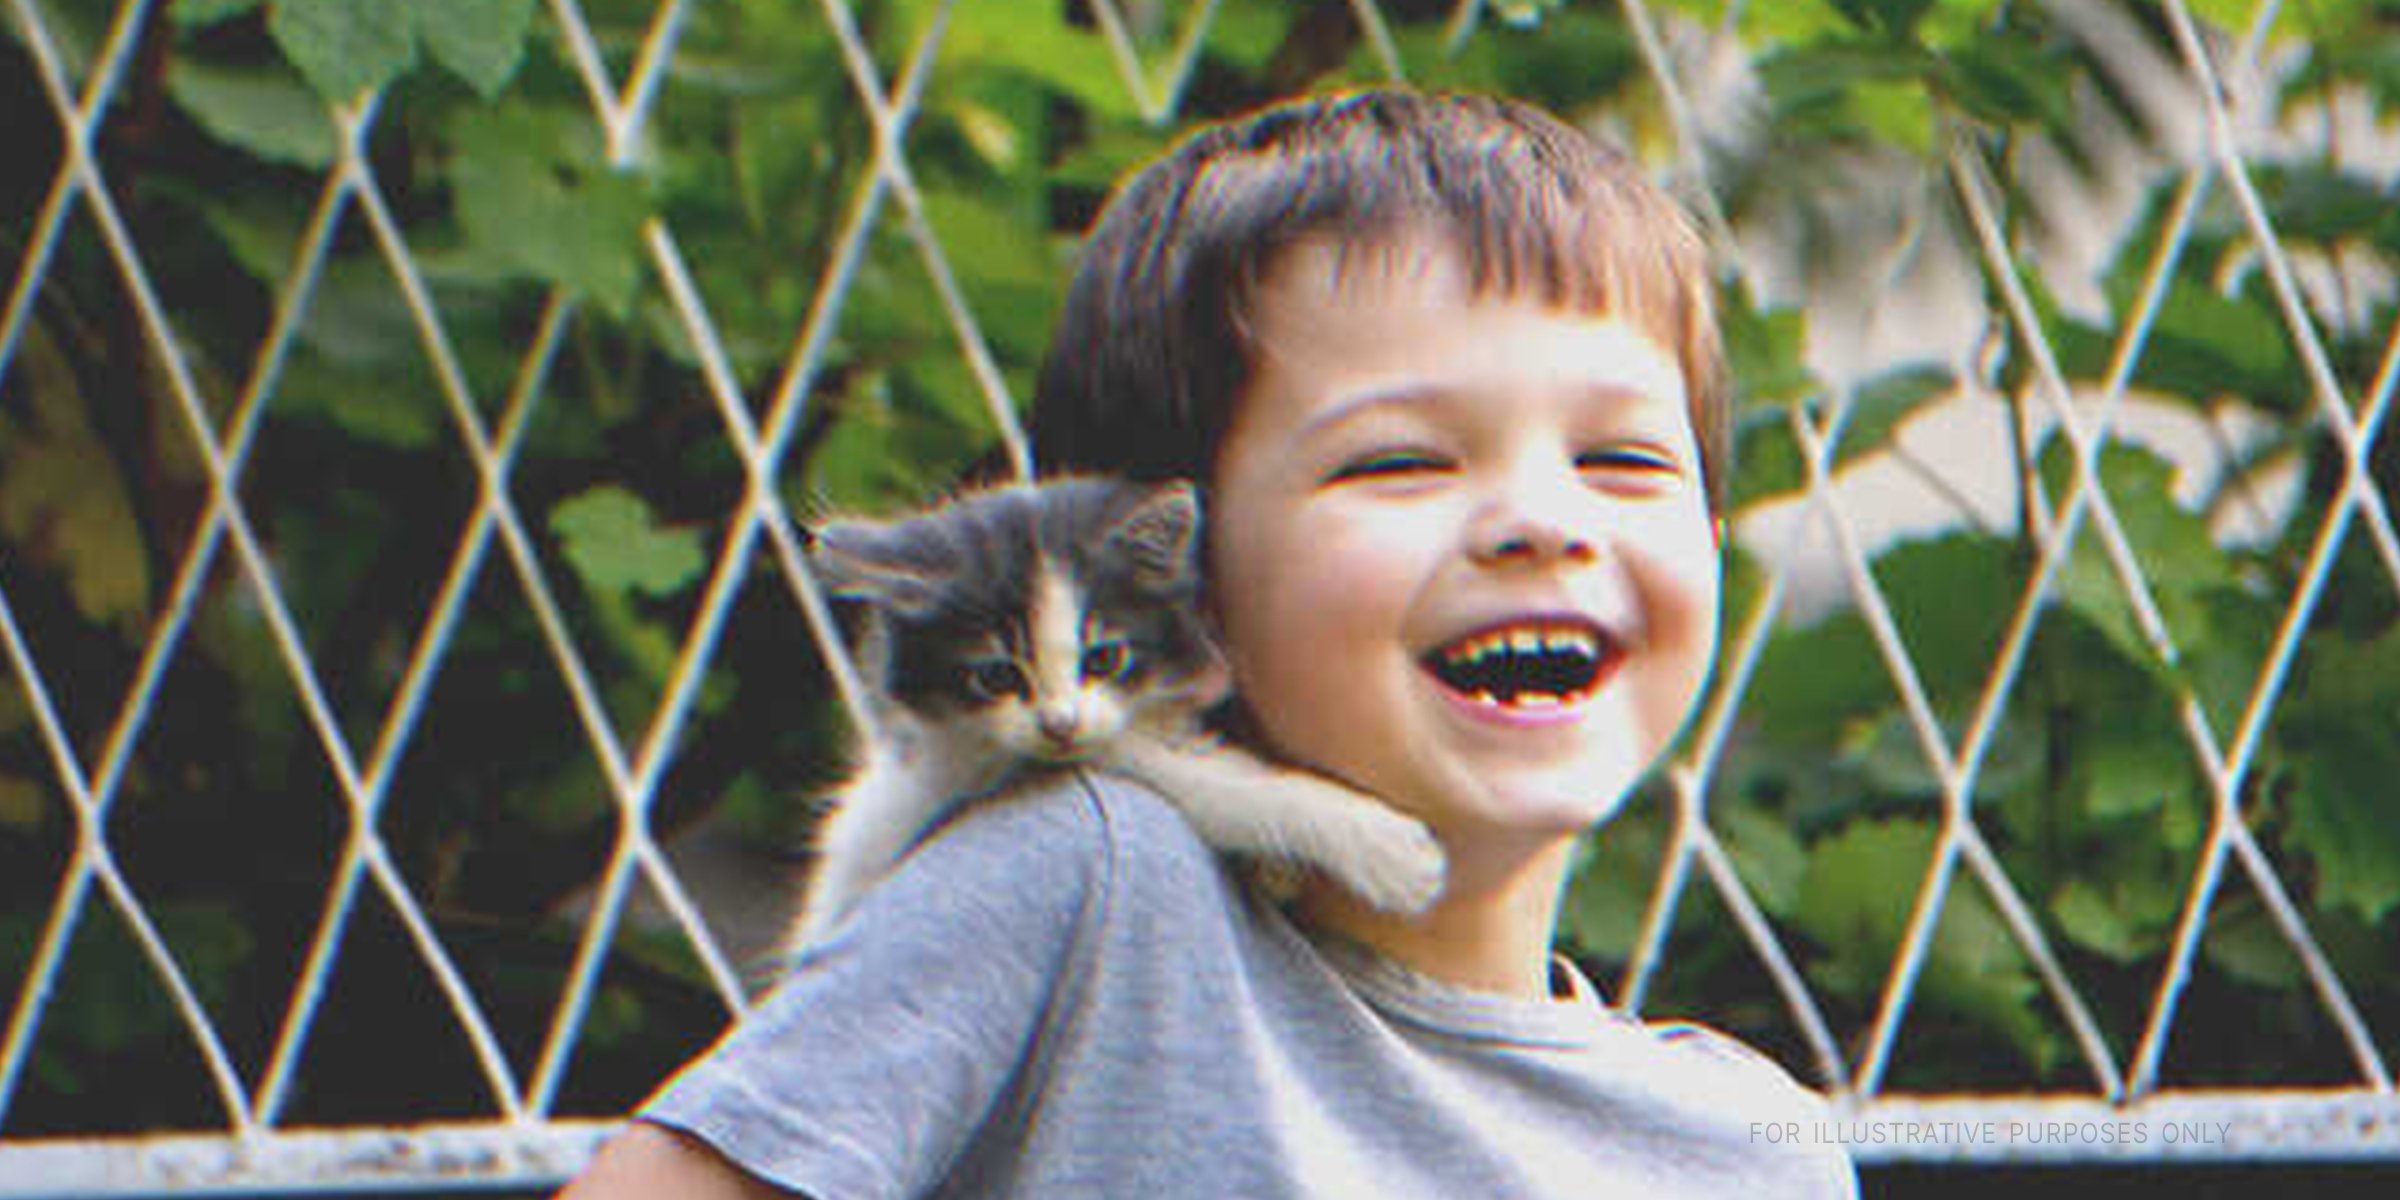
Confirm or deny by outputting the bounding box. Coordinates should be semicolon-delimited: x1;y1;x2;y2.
449;106;650;319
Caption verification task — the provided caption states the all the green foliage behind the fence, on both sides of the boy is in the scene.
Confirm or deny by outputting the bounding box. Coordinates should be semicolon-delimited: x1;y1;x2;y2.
0;0;2400;1133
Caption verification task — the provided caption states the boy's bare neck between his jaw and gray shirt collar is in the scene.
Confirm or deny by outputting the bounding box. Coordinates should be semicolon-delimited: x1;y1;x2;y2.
1298;842;1572;1001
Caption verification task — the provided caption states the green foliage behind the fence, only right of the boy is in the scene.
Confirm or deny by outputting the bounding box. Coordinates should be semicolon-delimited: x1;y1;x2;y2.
1570;0;2400;1087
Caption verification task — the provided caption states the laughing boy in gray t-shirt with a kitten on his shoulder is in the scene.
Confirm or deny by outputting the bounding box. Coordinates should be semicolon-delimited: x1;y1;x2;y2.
571;91;1855;1200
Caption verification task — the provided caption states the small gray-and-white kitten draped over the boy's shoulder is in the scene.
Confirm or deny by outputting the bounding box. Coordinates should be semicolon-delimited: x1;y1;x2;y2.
792;478;1445;948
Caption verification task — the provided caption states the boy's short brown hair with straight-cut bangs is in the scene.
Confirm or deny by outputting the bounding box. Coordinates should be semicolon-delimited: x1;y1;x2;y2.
1032;91;1728;504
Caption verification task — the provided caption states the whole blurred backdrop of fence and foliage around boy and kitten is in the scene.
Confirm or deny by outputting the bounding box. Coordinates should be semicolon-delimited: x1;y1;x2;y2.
0;0;2400;1195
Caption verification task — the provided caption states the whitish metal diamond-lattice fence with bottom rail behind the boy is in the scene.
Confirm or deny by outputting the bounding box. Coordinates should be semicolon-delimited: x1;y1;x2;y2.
0;0;2400;1195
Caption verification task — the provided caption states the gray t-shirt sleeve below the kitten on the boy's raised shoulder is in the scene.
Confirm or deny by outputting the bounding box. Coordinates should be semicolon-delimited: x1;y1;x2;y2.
638;780;1109;1200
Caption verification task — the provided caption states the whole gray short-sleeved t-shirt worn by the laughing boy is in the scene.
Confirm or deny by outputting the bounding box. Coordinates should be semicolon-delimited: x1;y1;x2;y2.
641;775;1858;1200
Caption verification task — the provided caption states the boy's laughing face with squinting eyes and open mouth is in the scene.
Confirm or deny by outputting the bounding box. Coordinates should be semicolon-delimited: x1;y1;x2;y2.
1210;240;1718;878
